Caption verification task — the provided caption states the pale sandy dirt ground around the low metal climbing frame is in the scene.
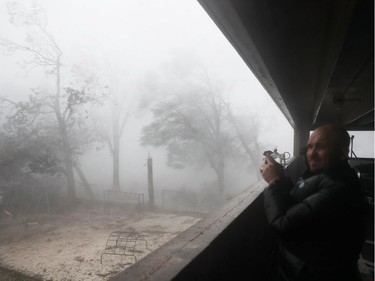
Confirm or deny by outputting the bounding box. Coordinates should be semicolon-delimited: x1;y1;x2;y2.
0;201;201;281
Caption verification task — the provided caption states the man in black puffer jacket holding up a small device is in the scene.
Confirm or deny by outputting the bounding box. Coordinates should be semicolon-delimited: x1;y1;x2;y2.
260;124;365;281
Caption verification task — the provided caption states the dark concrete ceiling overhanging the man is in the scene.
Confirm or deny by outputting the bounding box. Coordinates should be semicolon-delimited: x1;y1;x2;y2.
198;0;374;130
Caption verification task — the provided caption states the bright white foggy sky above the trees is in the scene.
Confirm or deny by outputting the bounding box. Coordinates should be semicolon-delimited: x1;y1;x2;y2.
0;0;291;142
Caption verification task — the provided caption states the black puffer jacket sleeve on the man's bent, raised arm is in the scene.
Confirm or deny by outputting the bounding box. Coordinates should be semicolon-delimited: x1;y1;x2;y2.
264;176;341;238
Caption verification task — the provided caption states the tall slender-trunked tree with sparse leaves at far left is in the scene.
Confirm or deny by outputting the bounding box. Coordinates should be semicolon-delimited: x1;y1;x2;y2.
0;2;100;201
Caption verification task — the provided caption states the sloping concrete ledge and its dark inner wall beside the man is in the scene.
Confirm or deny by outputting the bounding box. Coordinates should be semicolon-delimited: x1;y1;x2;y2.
110;181;273;281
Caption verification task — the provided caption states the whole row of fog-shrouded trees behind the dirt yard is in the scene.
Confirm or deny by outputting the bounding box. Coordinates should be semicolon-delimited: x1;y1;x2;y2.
0;1;290;214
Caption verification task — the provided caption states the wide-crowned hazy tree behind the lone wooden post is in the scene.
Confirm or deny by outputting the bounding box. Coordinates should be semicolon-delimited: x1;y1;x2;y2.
141;88;232;194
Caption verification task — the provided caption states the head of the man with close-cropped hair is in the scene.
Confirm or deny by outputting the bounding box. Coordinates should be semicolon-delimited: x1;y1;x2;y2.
306;124;350;172
